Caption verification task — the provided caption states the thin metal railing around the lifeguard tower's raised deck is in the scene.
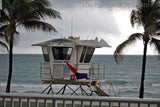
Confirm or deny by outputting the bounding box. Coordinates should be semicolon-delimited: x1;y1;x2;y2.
40;62;105;80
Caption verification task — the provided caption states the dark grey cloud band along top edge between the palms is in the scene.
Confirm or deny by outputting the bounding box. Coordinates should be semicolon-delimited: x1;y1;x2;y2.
51;0;137;9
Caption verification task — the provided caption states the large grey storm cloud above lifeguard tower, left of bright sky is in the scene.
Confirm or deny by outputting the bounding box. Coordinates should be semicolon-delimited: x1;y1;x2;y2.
0;0;136;53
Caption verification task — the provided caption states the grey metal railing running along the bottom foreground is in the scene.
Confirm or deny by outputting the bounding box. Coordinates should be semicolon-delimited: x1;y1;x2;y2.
0;93;160;107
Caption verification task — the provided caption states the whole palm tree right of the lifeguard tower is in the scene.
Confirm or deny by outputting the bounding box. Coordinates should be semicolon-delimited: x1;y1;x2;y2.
114;0;160;98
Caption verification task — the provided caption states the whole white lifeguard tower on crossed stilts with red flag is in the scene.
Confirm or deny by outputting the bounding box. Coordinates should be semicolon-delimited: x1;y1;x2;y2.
32;37;110;96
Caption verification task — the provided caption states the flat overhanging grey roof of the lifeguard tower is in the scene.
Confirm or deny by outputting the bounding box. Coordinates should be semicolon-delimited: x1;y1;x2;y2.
32;38;111;48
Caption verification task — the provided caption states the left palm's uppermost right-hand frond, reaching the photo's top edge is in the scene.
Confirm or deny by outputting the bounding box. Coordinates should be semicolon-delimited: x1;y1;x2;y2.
16;0;61;24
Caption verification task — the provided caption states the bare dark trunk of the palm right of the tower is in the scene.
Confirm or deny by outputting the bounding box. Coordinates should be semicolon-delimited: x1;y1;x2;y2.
139;41;148;98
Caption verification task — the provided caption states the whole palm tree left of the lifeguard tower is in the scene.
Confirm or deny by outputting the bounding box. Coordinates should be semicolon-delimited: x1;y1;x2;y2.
0;0;61;92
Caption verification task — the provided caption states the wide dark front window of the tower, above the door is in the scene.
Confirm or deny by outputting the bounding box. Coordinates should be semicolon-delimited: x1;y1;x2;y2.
52;47;72;60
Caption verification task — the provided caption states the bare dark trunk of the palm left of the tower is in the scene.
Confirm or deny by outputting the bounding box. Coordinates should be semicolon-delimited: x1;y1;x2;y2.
6;37;13;93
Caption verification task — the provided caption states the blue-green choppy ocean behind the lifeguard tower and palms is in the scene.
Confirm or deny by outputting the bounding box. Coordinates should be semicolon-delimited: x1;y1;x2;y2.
0;54;160;98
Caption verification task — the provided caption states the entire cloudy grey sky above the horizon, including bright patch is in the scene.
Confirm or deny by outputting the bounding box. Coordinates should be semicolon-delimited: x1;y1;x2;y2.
0;0;158;54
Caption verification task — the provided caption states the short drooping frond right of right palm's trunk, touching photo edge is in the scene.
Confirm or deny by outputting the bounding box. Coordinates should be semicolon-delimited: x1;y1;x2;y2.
150;37;160;55
